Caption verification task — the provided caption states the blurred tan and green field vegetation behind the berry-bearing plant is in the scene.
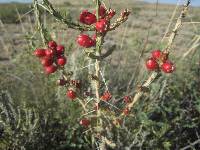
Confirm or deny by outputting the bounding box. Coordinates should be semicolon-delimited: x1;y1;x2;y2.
0;0;200;150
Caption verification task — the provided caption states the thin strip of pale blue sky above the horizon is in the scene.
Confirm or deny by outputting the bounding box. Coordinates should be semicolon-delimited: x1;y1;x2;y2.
0;0;200;6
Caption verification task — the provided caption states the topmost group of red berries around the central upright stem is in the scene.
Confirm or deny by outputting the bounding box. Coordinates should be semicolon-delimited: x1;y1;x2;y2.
77;5;115;48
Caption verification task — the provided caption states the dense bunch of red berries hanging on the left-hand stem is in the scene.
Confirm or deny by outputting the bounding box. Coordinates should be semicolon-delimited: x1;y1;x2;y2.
34;41;67;74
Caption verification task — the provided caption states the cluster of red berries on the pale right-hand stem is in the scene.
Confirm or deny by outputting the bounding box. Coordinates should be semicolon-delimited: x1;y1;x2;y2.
146;50;175;73
